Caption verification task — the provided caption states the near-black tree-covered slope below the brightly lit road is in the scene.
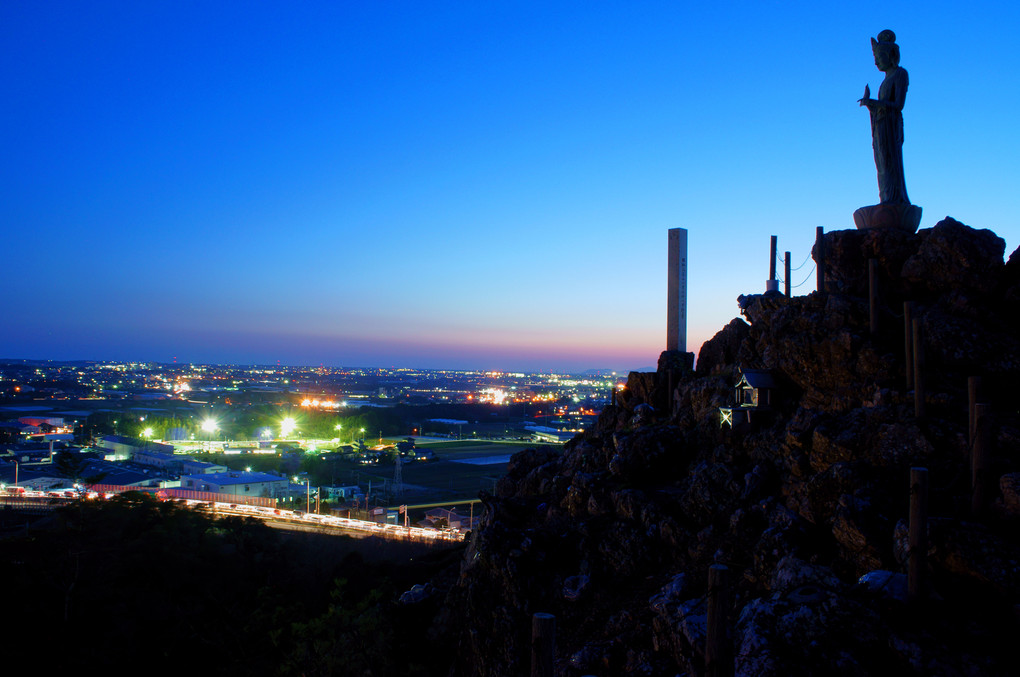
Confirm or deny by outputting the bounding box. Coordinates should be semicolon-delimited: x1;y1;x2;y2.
0;492;462;677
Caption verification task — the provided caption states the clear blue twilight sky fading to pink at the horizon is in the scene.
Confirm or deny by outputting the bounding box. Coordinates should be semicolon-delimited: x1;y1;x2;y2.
0;0;1020;370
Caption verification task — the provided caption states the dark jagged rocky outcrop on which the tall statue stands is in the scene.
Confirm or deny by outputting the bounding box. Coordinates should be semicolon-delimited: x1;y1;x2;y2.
440;219;1020;676
